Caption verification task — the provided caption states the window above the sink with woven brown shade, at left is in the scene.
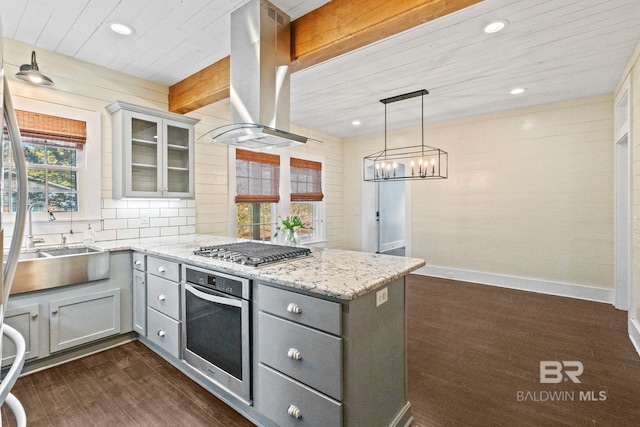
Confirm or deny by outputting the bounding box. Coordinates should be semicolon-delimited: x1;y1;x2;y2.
2;110;86;212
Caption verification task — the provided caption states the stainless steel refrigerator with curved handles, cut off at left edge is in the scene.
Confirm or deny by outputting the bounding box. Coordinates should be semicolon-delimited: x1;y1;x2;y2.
0;24;27;427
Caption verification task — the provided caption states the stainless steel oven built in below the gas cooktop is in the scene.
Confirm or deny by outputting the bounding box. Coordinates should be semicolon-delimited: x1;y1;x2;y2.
182;266;252;404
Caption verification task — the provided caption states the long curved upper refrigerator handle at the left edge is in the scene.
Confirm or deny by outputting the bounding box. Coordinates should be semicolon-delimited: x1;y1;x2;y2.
2;79;27;307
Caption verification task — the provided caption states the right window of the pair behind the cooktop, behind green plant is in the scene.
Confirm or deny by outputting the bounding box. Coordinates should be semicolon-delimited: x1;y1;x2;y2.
289;157;324;240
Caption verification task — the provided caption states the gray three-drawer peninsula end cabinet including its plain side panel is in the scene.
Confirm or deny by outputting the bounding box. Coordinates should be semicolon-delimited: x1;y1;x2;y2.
253;278;412;427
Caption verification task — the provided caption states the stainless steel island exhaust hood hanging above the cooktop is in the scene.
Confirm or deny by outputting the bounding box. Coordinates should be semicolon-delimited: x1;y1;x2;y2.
200;0;309;150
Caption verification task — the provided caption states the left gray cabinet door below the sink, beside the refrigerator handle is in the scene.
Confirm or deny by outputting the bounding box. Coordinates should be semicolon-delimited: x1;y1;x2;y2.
2;304;40;366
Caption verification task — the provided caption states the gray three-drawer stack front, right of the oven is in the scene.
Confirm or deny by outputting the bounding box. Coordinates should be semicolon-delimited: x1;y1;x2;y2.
254;285;343;427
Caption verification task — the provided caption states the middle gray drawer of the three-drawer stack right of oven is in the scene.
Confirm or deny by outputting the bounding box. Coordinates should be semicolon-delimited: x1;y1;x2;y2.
258;313;342;400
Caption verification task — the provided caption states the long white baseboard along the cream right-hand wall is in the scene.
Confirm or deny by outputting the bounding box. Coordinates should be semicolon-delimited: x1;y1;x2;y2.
413;265;615;304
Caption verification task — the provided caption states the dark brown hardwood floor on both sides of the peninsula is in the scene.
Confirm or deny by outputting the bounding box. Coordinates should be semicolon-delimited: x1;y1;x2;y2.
2;275;640;427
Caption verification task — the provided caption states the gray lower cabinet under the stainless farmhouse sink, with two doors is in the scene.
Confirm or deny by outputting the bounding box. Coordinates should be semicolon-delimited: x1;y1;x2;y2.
2;251;133;366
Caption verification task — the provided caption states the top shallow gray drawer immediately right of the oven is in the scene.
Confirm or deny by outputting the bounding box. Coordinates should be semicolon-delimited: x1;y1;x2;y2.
258;285;342;335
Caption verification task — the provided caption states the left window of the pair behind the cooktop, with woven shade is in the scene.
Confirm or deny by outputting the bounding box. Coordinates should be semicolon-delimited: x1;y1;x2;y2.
235;149;280;241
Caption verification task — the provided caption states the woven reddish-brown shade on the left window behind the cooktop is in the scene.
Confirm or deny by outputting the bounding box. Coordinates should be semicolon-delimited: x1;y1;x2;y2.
236;149;280;203
